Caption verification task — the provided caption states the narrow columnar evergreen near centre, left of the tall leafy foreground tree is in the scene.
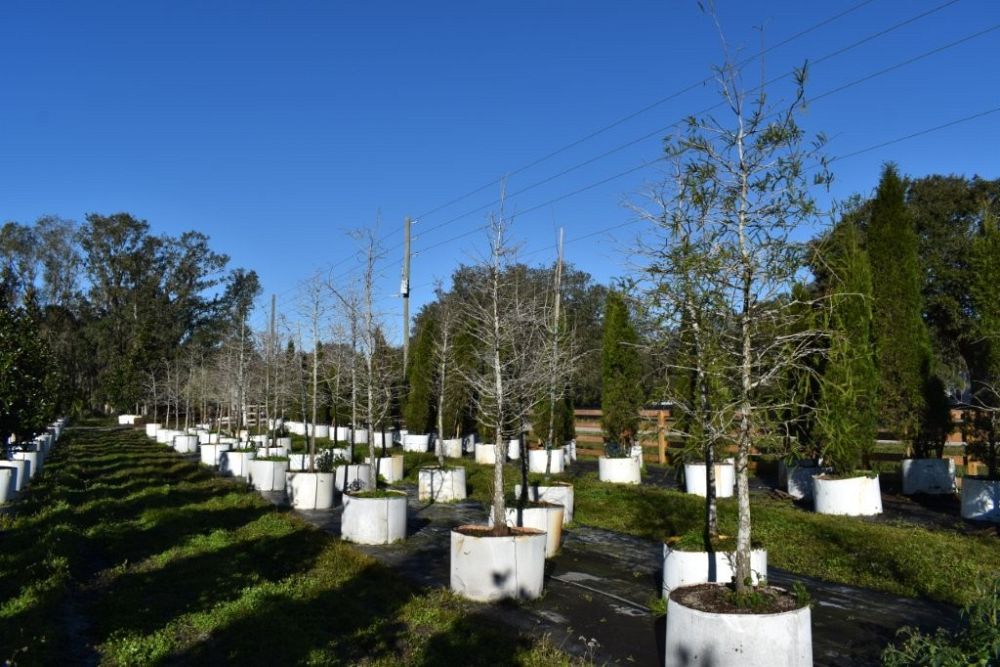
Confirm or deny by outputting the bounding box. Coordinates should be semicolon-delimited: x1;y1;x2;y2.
601;290;643;448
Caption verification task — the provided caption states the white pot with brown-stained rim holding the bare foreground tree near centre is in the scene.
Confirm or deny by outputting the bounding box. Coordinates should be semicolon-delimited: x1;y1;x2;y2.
451;526;545;602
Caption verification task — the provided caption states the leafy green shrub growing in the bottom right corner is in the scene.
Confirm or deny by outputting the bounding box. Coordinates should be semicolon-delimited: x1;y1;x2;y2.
882;579;1000;667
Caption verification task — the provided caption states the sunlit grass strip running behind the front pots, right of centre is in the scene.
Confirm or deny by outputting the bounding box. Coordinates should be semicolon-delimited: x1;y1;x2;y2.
406;454;1000;606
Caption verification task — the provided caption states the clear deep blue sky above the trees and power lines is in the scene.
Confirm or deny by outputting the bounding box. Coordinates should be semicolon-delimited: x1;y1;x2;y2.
0;0;1000;340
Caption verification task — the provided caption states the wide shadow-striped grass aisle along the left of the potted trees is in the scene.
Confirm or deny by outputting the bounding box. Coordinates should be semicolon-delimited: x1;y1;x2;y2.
0;430;569;665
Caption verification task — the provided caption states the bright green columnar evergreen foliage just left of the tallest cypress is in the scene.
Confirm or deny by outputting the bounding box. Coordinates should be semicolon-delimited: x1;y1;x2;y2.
815;220;879;474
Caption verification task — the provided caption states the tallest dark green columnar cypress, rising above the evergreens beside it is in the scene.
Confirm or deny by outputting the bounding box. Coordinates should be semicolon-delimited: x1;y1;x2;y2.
868;164;931;441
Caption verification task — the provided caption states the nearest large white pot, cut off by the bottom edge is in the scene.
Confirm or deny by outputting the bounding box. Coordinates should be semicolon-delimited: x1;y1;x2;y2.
666;598;813;667
